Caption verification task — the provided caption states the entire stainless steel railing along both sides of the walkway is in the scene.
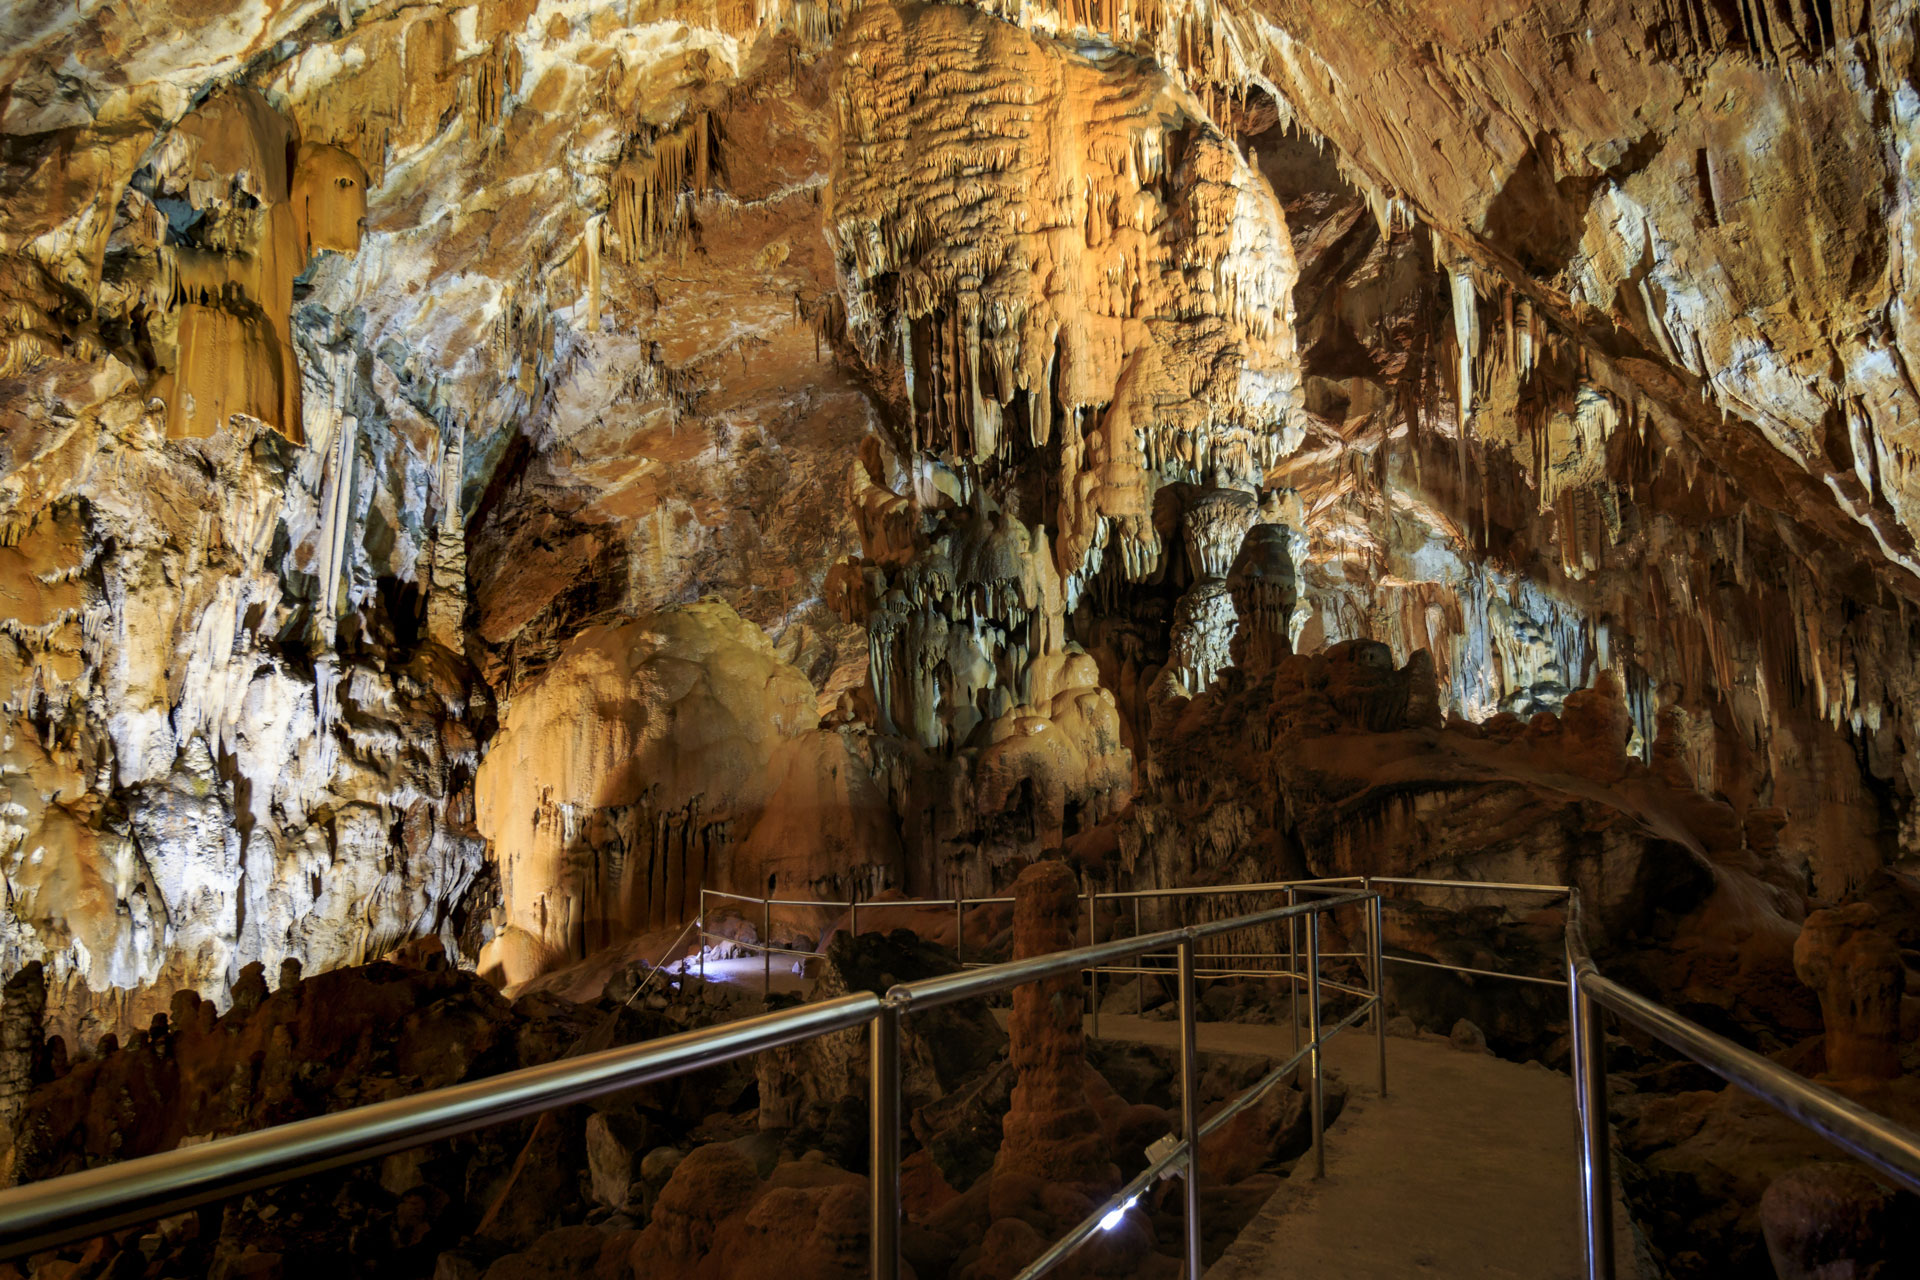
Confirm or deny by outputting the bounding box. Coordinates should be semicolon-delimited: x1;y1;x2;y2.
26;859;1920;1280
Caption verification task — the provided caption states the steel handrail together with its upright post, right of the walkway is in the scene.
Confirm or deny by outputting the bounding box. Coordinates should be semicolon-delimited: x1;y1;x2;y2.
1567;890;1920;1280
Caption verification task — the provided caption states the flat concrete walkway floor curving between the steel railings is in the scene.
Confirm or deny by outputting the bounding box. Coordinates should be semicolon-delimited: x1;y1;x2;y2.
1100;1013;1634;1280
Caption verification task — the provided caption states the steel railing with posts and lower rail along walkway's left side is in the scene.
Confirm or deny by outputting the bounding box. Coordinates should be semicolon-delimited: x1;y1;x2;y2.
0;892;1386;1280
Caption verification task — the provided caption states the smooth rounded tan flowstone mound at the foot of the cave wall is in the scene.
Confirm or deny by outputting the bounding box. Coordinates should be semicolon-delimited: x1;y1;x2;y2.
476;603;897;983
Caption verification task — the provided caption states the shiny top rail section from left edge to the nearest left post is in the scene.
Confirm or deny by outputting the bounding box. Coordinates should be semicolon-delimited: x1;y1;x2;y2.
0;992;879;1259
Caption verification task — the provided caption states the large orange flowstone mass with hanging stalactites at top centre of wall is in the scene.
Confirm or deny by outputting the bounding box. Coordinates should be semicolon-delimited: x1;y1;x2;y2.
828;6;1302;608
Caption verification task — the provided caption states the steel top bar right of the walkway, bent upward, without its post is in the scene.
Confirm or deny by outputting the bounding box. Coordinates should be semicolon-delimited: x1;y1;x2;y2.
1567;894;1920;1194
